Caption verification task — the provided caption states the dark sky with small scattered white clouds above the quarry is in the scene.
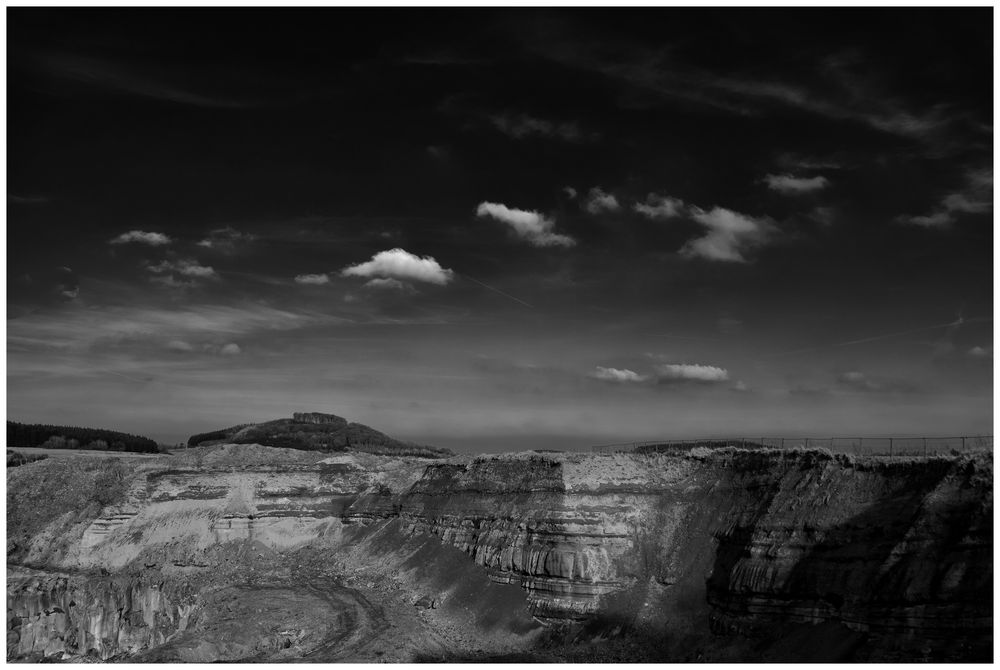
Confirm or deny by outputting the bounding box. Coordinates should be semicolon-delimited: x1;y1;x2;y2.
6;7;994;452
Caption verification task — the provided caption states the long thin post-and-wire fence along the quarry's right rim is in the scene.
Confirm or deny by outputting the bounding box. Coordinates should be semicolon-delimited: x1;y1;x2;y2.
587;435;993;457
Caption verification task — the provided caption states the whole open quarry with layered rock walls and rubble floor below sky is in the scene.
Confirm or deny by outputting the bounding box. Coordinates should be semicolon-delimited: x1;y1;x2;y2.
7;436;993;662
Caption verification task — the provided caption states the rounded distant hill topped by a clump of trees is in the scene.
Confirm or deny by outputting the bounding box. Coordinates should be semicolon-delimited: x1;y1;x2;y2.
188;412;452;458
